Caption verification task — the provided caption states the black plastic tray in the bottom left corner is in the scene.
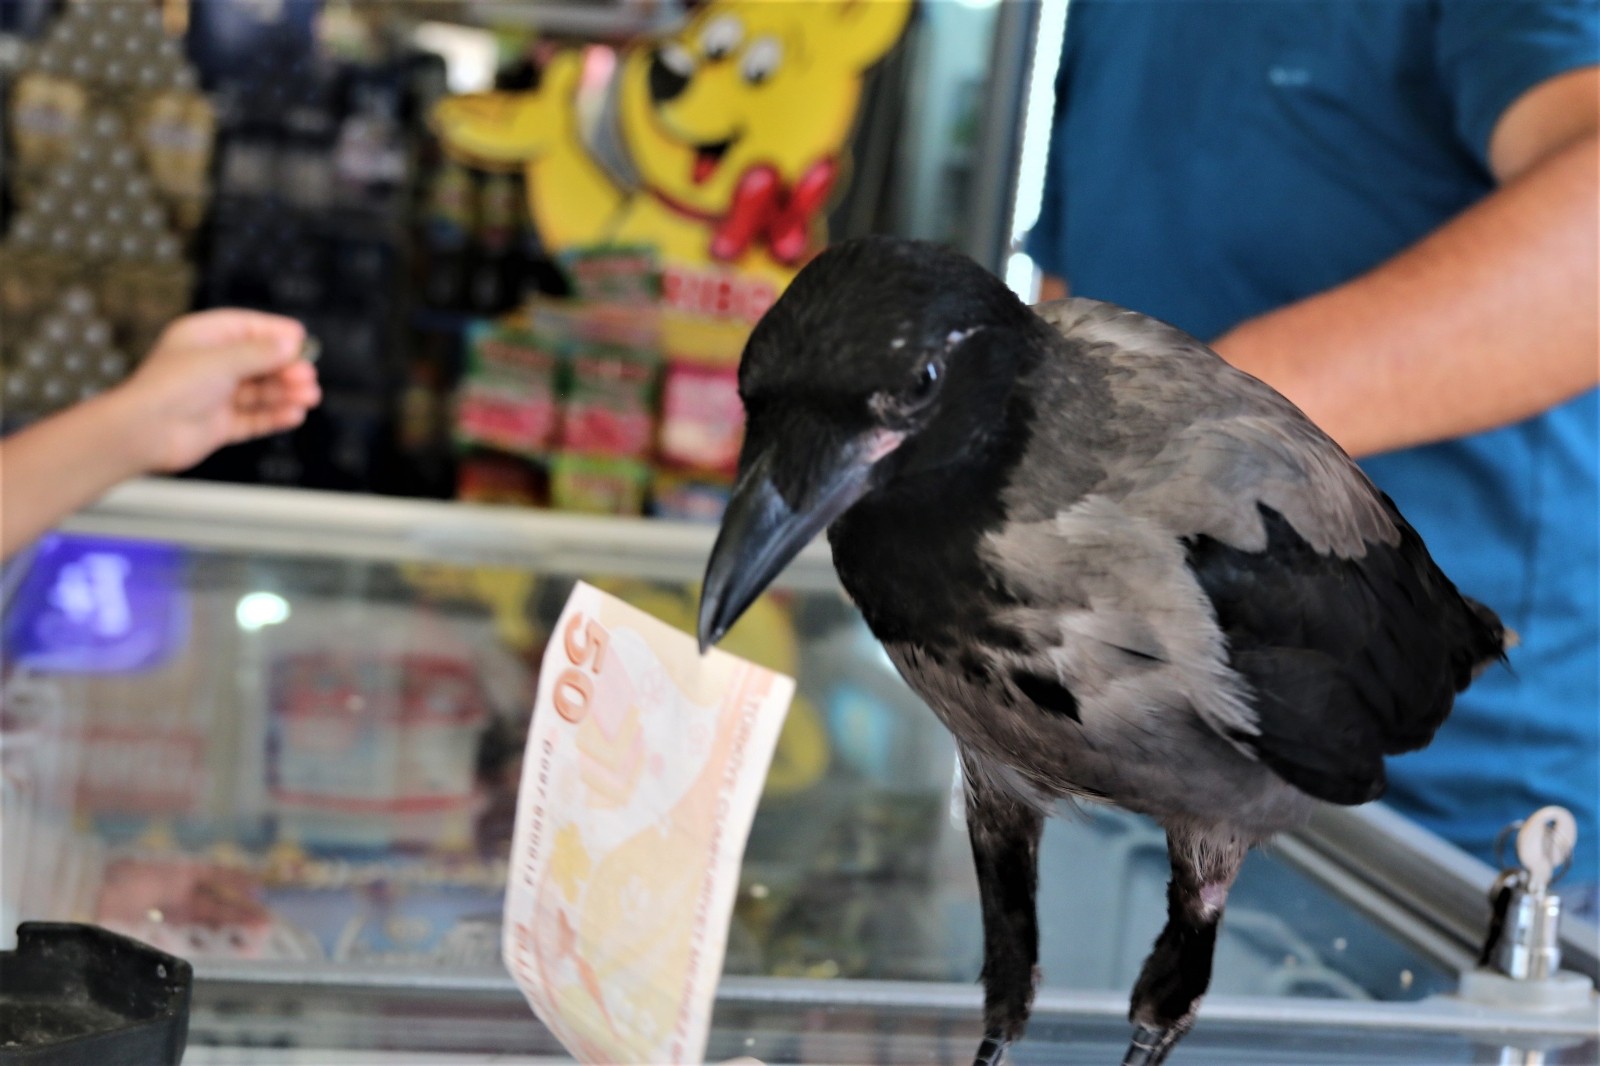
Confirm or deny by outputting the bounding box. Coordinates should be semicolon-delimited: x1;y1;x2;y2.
0;922;194;1066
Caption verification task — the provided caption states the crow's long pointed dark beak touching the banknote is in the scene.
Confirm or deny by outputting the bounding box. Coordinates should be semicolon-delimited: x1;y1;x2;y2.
699;429;902;653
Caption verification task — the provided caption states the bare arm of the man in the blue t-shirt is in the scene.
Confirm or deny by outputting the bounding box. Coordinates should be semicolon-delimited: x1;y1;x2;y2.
1214;67;1600;455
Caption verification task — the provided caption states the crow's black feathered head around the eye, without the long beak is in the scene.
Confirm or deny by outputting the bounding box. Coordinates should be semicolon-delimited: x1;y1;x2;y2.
739;237;1040;509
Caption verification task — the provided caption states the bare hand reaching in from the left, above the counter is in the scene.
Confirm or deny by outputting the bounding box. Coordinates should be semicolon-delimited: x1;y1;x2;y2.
107;309;322;472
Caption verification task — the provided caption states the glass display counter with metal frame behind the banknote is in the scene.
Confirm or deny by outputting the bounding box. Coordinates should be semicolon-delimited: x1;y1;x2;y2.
0;482;1600;1066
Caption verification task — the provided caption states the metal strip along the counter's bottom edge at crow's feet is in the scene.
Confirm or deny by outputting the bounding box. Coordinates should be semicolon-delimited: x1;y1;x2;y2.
190;965;1600;1066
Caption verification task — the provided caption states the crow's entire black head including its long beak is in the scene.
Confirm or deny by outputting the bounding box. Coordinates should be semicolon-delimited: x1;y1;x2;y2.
699;237;1048;645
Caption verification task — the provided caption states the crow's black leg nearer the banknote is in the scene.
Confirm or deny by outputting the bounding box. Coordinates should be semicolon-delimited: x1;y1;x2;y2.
962;755;1045;1066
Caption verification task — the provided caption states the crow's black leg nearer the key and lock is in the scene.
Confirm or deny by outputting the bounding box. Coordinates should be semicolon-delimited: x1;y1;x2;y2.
1122;829;1250;1066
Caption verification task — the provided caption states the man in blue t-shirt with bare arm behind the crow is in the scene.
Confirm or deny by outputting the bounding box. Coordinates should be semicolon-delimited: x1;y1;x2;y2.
1026;0;1600;916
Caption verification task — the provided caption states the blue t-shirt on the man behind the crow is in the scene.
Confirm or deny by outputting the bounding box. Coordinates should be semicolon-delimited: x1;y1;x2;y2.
1027;0;1600;882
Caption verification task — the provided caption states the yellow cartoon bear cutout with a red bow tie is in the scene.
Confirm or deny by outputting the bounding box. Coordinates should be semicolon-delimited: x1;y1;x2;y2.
434;0;910;365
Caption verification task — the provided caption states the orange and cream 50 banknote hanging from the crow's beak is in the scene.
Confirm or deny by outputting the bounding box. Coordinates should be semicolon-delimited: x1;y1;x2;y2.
501;583;794;1063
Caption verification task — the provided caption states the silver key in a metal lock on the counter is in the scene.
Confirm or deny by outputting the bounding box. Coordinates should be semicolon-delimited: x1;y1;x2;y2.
1478;807;1578;981
